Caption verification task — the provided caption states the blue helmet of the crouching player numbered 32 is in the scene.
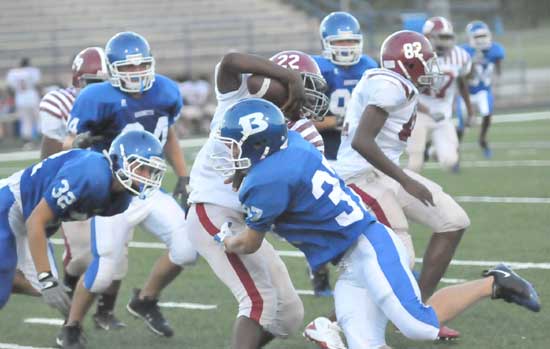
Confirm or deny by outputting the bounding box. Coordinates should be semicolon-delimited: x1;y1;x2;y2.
108;130;166;199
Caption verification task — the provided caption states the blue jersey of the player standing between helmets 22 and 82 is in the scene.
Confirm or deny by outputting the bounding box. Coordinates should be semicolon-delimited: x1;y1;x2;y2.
312;55;378;160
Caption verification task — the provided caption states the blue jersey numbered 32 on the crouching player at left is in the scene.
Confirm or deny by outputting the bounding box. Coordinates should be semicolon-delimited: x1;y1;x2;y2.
19;149;132;233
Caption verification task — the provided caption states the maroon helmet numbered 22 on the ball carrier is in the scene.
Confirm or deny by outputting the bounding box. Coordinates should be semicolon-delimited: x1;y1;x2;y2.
269;51;329;120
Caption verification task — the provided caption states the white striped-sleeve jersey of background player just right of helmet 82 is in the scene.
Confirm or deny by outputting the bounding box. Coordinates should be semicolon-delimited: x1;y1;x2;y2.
419;46;472;121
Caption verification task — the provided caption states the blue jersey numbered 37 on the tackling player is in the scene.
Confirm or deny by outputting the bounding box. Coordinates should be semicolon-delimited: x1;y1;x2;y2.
239;131;375;270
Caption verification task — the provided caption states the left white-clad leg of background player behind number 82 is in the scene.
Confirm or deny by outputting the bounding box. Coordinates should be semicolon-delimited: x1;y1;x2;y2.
407;112;434;172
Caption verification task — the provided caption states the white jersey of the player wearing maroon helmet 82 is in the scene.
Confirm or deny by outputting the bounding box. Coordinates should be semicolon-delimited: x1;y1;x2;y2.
333;69;418;180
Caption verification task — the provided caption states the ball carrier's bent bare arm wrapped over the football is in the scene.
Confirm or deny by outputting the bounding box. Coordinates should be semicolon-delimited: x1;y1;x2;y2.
216;52;305;116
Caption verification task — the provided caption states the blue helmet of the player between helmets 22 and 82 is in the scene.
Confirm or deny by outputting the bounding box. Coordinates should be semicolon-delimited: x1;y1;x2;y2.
319;12;363;65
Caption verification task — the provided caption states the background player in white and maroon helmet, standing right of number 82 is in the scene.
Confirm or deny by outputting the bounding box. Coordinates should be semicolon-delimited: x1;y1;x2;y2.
407;17;473;172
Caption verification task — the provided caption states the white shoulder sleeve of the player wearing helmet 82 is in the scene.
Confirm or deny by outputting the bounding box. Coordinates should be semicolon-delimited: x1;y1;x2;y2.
363;78;407;113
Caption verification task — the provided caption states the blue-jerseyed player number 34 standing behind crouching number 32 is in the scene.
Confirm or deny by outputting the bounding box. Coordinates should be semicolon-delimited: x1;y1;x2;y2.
62;32;197;346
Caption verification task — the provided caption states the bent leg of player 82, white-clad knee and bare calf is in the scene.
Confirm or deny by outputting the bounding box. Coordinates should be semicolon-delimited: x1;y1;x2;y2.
397;170;470;300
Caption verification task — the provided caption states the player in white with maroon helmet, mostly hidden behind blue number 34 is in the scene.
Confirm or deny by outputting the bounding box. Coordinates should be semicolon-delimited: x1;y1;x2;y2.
39;47;125;330
